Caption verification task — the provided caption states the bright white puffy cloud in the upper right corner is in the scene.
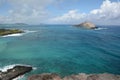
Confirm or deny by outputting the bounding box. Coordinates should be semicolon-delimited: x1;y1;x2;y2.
90;0;120;20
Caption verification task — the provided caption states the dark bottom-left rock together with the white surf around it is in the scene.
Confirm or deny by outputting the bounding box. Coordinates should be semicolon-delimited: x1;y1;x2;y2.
0;64;33;80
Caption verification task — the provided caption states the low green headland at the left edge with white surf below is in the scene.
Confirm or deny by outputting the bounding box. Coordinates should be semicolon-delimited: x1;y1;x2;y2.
0;29;24;36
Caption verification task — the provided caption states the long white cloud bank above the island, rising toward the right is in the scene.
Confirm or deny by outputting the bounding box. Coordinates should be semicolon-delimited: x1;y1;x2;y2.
51;0;120;25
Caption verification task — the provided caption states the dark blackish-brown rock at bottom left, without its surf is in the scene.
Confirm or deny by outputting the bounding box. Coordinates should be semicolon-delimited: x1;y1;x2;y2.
0;66;32;80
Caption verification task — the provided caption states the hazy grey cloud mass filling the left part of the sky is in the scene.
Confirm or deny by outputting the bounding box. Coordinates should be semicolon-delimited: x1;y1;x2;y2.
0;0;54;24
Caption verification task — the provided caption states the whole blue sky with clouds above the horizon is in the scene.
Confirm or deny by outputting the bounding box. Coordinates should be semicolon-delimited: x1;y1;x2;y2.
0;0;120;25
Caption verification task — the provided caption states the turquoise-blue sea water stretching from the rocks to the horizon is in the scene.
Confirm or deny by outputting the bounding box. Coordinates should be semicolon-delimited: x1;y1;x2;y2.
0;25;120;79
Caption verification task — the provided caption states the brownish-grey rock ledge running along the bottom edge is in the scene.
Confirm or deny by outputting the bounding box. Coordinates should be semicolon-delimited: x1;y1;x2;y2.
28;73;120;80
